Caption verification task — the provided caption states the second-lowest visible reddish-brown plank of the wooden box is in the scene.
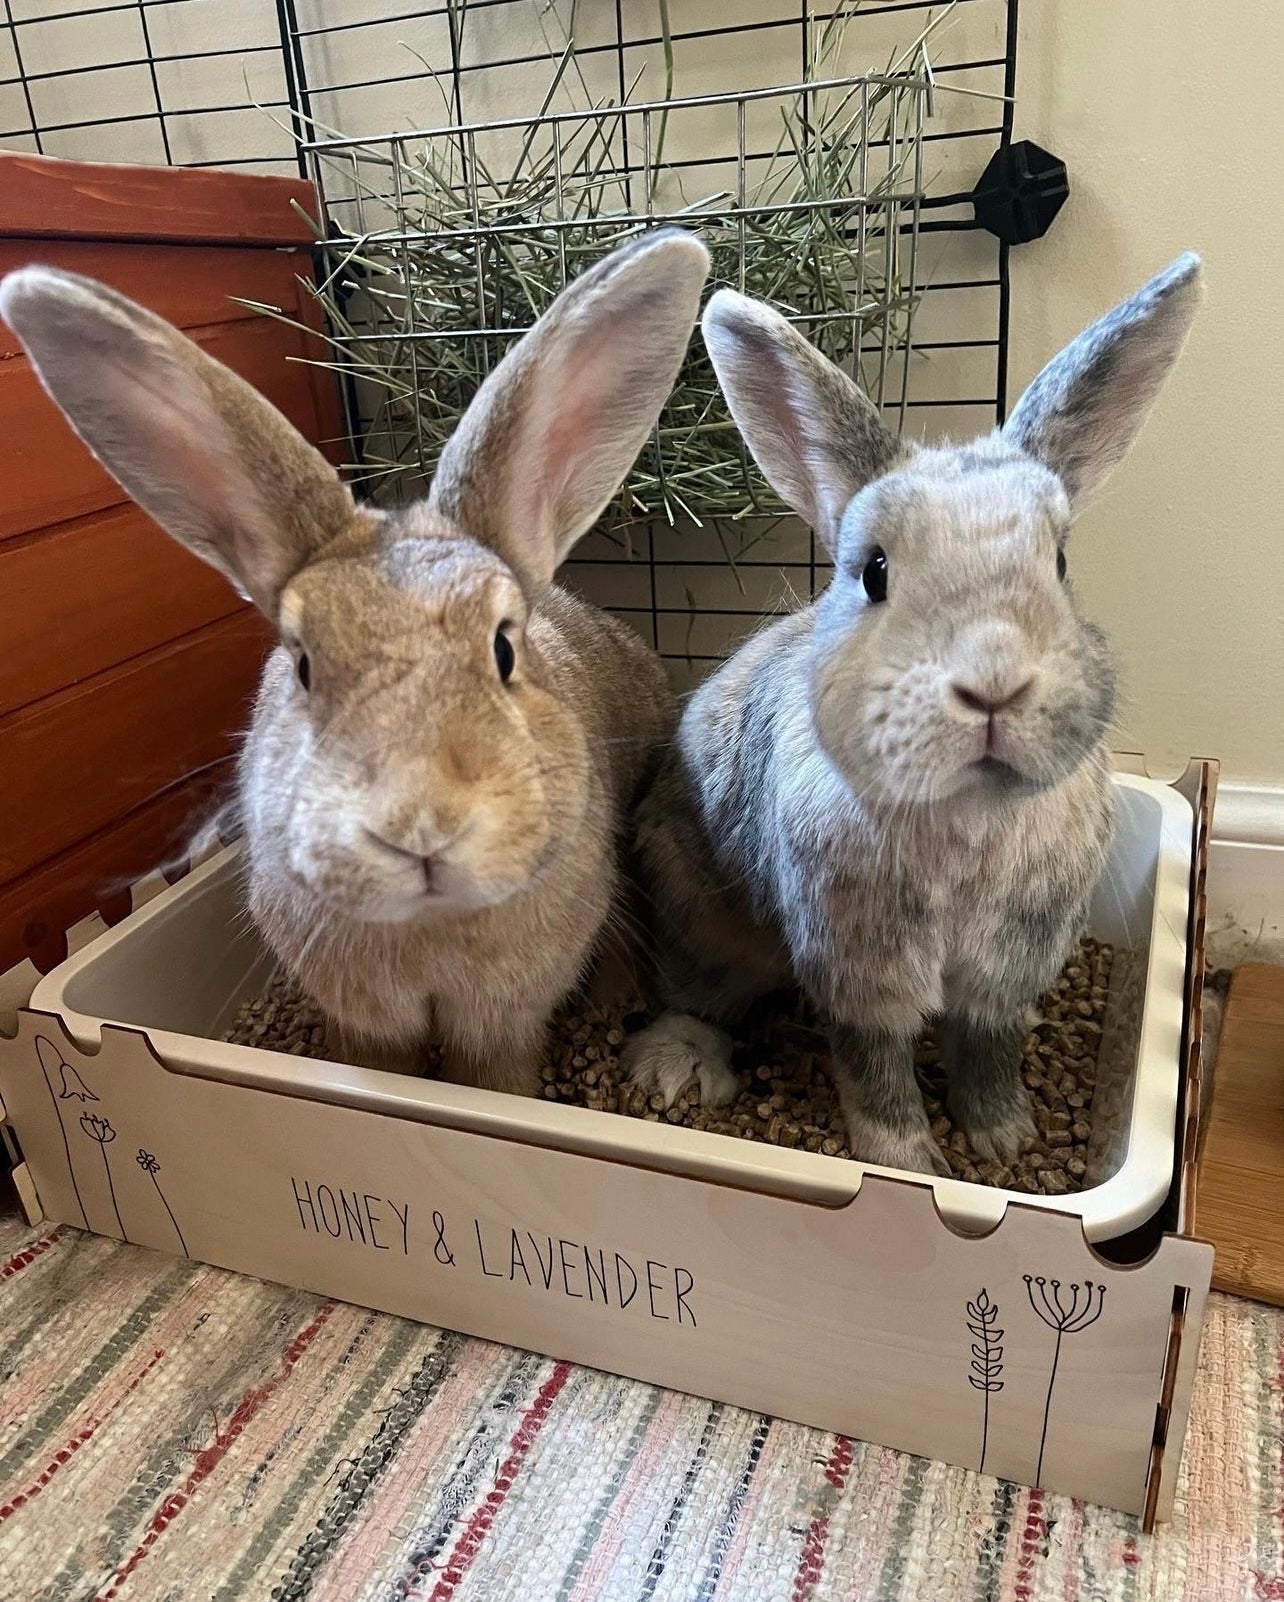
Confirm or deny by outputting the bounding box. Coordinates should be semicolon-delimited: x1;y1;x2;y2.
0;607;271;883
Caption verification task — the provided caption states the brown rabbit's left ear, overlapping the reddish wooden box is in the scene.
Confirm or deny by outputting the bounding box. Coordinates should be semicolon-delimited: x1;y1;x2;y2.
0;268;353;618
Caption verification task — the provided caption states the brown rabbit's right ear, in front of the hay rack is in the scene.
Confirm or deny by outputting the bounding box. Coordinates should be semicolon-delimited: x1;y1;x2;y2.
430;229;709;599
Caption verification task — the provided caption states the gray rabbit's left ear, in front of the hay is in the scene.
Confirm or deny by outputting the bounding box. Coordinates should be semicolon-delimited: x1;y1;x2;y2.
704;290;901;551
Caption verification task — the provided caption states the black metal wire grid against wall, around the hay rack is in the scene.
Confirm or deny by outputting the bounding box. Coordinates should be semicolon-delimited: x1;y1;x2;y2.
0;0;1018;679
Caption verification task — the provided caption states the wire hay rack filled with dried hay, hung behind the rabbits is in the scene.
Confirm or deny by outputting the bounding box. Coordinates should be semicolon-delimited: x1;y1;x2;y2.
298;14;930;538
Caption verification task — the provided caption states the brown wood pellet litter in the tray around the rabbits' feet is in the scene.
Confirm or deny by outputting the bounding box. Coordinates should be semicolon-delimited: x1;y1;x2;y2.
224;939;1114;1195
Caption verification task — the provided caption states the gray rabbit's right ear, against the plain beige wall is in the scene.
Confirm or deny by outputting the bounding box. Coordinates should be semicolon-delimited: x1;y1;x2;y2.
1003;252;1201;505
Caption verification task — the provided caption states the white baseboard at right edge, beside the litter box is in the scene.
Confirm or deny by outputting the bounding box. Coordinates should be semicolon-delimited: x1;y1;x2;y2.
1209;783;1284;966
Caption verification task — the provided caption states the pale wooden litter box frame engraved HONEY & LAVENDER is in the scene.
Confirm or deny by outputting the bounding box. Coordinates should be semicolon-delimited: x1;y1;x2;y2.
0;763;1215;1528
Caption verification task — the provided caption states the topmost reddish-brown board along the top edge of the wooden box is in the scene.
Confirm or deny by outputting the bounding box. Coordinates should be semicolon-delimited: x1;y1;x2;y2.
0;154;316;245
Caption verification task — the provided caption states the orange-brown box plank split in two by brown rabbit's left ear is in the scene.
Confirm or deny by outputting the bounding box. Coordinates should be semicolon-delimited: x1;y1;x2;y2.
0;317;335;540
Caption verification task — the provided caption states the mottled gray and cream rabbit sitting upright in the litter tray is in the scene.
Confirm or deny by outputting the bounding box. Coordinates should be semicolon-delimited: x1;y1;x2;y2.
625;255;1199;1174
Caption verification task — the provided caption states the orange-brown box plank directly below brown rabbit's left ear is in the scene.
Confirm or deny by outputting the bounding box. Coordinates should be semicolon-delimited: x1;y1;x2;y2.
0;503;244;716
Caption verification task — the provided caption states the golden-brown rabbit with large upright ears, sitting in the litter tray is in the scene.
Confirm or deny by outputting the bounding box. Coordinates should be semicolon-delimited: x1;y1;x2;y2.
0;231;709;1093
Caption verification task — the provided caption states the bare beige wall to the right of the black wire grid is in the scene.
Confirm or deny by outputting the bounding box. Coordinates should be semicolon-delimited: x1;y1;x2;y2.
1011;0;1284;785
